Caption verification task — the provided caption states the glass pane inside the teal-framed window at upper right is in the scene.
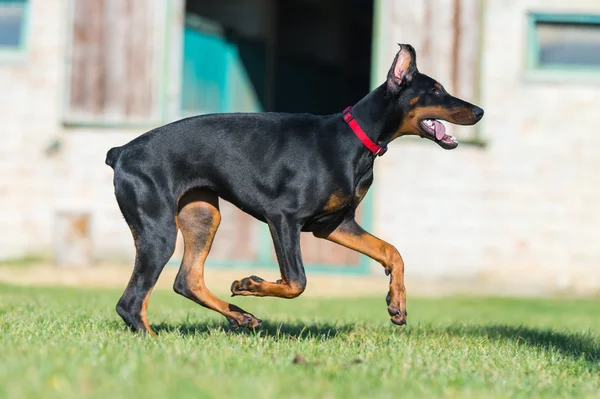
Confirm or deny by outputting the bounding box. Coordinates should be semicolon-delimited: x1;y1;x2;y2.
536;22;600;67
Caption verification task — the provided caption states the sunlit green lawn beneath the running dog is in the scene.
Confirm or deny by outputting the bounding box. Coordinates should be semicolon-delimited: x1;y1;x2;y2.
0;285;600;398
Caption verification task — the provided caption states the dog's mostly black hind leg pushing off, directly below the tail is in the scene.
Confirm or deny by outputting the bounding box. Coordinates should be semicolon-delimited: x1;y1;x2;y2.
117;208;177;335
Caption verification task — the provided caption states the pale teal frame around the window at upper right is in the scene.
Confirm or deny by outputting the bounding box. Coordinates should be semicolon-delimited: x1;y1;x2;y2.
526;12;600;78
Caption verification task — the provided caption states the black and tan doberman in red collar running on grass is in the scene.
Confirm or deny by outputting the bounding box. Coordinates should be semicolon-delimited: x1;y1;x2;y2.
106;44;483;334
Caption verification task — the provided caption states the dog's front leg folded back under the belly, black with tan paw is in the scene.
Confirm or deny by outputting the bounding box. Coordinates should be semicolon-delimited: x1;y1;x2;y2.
231;215;306;298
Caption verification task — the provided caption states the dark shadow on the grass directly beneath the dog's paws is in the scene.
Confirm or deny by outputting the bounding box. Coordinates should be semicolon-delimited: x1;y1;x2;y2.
152;320;354;339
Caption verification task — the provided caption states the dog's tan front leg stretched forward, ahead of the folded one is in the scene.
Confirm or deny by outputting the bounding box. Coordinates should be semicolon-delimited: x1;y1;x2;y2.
314;218;407;325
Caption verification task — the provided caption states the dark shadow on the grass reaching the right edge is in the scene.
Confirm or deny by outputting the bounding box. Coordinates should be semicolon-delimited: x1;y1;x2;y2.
445;325;600;366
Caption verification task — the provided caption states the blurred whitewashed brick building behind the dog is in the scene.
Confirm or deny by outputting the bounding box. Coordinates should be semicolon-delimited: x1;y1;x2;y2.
0;0;600;292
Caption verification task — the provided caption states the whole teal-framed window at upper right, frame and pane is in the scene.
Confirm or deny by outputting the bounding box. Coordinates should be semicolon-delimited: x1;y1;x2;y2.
528;14;600;73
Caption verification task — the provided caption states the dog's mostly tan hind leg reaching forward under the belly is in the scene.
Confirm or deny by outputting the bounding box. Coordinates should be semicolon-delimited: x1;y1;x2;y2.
173;190;261;329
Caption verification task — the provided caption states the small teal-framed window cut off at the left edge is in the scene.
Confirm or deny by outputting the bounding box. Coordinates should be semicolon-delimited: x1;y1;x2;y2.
0;0;27;51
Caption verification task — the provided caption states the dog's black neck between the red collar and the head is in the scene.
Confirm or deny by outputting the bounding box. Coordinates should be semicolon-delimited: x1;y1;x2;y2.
352;83;404;146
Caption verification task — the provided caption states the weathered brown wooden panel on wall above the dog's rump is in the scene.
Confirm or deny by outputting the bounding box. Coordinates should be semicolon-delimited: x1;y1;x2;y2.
65;0;165;126
